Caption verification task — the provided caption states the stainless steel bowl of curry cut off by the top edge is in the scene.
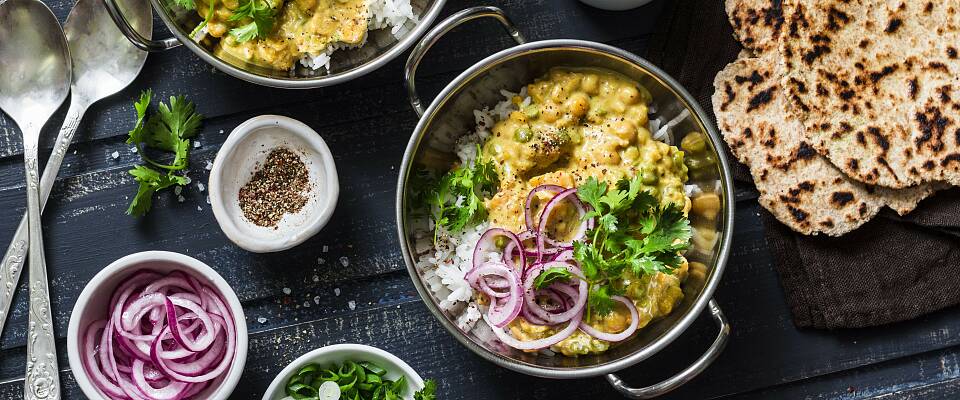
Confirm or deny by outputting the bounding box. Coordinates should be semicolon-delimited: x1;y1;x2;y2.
104;0;446;89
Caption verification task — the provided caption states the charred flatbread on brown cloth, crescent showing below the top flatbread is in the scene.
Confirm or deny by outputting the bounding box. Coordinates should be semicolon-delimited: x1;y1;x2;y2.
713;53;937;236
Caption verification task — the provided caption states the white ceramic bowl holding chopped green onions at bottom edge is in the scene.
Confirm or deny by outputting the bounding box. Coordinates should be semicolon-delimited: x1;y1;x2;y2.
263;343;423;400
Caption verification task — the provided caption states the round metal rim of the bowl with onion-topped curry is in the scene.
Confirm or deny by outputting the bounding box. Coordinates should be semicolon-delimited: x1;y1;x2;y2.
395;39;735;379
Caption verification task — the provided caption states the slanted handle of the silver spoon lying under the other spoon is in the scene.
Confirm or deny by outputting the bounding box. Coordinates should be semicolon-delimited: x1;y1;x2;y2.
0;96;87;337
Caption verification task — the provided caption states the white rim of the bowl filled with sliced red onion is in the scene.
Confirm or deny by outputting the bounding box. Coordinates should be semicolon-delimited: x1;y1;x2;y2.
67;250;248;400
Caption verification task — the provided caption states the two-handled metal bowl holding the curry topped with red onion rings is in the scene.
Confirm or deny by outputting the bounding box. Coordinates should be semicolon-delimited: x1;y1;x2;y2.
396;7;734;398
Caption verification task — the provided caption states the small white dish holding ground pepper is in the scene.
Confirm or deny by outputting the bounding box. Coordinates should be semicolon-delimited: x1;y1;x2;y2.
208;115;340;253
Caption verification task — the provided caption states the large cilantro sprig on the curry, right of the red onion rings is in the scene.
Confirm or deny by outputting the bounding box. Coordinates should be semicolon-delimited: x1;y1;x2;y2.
573;177;692;315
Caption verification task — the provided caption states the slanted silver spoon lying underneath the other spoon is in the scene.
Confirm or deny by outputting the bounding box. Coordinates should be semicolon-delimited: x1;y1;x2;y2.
0;0;153;334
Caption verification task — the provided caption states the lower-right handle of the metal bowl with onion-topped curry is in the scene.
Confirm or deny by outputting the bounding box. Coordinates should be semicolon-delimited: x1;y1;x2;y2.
607;299;730;399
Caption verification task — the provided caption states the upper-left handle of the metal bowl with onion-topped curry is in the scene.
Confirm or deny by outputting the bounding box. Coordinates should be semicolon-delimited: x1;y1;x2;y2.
404;6;527;117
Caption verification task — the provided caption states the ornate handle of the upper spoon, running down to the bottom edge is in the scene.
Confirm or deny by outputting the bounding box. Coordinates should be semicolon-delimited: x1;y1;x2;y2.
23;138;60;400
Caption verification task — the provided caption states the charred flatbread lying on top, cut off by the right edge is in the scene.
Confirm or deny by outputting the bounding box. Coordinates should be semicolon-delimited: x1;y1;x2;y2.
780;0;960;188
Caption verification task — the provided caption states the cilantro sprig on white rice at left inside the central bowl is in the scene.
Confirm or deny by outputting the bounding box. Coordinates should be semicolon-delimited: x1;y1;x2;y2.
426;146;500;239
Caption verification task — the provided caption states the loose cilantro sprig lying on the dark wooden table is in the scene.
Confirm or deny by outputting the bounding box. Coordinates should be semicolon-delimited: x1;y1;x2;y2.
127;89;203;217
